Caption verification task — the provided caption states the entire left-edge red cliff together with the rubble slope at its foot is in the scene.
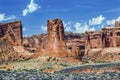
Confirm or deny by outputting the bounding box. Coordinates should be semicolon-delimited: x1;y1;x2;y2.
0;21;32;63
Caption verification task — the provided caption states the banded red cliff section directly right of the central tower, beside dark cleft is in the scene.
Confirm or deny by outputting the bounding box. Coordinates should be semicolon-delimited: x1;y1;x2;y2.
65;32;85;60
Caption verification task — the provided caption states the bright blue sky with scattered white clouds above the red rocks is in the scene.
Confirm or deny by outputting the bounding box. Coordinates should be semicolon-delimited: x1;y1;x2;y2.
0;0;120;36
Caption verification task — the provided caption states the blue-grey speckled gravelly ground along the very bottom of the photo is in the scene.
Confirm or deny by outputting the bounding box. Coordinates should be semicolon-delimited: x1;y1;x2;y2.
0;70;120;80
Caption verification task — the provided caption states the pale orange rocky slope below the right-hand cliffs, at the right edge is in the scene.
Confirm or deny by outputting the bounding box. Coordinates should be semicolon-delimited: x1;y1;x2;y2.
82;47;120;62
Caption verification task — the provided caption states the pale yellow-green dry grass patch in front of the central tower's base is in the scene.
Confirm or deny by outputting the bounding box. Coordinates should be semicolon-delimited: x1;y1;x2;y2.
0;56;81;72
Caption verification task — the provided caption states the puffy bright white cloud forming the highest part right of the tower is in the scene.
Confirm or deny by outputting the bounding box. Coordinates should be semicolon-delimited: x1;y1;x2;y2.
89;15;105;25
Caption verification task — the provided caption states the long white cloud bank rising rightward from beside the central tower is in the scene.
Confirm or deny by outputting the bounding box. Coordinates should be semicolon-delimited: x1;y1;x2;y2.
64;15;105;33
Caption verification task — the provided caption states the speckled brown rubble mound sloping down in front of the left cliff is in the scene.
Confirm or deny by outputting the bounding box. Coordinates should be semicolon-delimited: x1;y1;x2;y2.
0;39;29;64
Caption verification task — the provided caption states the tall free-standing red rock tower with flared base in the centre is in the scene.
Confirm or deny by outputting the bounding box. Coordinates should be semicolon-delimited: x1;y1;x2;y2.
46;19;67;56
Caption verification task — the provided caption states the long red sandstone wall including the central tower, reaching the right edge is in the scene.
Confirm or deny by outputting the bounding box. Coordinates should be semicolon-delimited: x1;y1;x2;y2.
20;19;120;60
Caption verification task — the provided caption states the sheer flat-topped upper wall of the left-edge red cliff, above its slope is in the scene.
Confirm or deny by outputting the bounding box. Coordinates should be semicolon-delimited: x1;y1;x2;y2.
0;21;22;45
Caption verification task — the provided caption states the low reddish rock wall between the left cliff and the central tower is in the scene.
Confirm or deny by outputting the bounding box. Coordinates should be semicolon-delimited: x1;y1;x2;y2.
23;34;47;52
